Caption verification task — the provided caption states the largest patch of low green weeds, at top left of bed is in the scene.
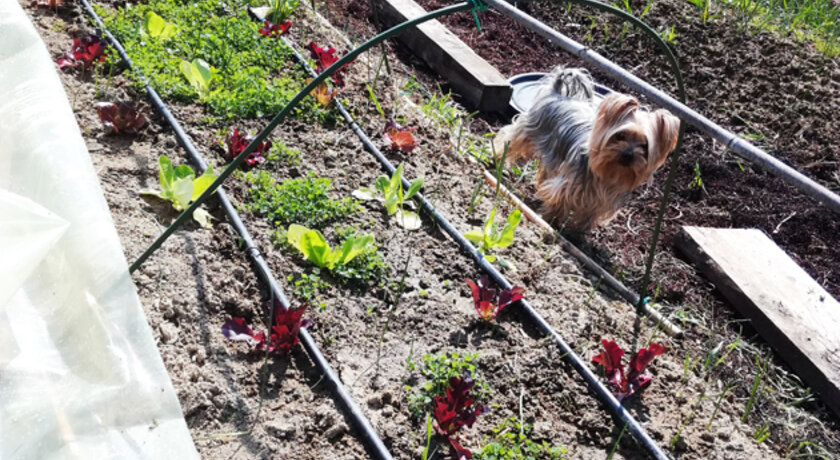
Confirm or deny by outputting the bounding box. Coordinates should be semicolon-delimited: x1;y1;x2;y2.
97;0;330;118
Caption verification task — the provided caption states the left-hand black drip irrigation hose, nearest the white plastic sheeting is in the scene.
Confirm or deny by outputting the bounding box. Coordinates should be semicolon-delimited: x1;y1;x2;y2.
81;0;393;460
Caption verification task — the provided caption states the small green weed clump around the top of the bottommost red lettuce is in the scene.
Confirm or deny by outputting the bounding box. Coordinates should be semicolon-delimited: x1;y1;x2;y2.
406;353;493;417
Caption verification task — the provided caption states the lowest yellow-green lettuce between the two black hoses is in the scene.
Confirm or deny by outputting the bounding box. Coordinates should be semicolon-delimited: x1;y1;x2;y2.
286;224;374;270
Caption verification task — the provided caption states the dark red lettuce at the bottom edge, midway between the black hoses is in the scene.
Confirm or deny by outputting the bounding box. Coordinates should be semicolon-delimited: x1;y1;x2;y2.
432;372;487;460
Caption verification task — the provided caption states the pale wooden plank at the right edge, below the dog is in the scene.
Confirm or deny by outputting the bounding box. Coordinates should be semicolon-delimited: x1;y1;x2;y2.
677;227;840;415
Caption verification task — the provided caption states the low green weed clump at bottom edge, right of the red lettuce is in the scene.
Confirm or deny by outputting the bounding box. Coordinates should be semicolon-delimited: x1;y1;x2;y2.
473;418;567;460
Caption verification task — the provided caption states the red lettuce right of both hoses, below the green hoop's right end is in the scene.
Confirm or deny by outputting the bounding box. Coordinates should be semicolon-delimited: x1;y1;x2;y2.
592;339;665;401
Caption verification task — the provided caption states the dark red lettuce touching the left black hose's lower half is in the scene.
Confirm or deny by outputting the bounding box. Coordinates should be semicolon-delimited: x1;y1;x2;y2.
222;300;312;354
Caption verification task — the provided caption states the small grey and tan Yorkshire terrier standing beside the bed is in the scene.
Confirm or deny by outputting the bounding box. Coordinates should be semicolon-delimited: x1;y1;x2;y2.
493;67;680;231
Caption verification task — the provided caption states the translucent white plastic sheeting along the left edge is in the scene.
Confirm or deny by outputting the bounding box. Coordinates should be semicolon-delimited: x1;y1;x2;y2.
0;0;198;460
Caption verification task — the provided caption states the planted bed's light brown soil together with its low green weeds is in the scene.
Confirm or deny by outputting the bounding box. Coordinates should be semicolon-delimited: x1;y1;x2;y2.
18;0;840;458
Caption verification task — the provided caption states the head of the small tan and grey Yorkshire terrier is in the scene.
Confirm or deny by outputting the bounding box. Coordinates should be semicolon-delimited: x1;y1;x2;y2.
589;93;680;191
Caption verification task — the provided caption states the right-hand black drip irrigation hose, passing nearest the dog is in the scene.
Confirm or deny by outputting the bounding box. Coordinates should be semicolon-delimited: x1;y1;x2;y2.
276;7;669;459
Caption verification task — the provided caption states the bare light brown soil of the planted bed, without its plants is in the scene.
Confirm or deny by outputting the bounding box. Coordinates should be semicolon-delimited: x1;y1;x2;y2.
18;0;840;459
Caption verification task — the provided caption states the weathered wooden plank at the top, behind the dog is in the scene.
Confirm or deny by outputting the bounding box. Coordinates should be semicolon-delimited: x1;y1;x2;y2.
374;0;513;113
